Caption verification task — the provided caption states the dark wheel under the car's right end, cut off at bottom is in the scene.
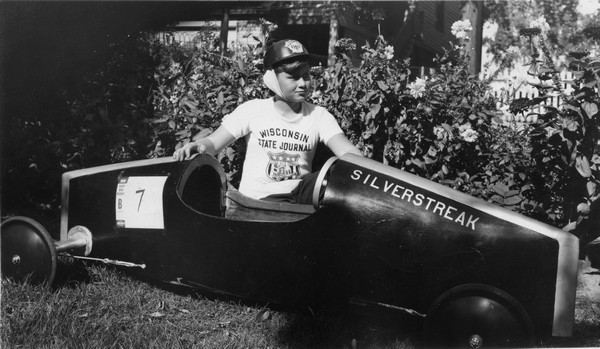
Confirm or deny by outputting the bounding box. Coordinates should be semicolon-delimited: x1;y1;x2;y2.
424;284;535;348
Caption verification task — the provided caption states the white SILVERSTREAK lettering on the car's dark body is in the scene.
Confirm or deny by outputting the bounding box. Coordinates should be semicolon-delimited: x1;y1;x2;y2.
350;170;479;230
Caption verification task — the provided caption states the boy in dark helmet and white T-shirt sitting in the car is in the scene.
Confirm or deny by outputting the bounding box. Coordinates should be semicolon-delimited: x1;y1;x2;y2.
173;40;362;204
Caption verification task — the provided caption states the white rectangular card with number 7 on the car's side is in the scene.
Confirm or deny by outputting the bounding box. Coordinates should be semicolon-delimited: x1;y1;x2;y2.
115;176;167;229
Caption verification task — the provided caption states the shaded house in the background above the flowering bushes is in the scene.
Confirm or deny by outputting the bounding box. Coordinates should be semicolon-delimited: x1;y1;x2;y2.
162;0;482;72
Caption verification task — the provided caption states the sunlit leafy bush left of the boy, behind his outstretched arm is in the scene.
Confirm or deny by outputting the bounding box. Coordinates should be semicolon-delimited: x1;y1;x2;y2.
151;20;276;183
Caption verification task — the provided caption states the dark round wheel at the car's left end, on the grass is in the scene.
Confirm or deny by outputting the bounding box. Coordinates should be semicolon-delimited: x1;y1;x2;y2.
0;217;57;285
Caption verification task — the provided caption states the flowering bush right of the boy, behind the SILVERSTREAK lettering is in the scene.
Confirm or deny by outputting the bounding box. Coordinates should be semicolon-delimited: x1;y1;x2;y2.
314;21;531;211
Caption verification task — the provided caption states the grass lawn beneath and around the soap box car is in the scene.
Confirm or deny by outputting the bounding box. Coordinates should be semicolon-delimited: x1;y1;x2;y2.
0;261;600;348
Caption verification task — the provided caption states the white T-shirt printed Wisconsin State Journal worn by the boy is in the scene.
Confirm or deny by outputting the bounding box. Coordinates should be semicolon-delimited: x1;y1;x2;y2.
221;98;342;199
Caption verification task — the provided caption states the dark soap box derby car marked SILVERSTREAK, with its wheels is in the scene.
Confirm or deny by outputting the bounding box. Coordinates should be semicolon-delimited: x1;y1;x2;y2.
2;155;579;347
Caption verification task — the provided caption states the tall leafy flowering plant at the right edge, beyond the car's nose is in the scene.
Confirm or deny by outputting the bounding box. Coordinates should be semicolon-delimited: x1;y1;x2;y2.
510;17;600;241
